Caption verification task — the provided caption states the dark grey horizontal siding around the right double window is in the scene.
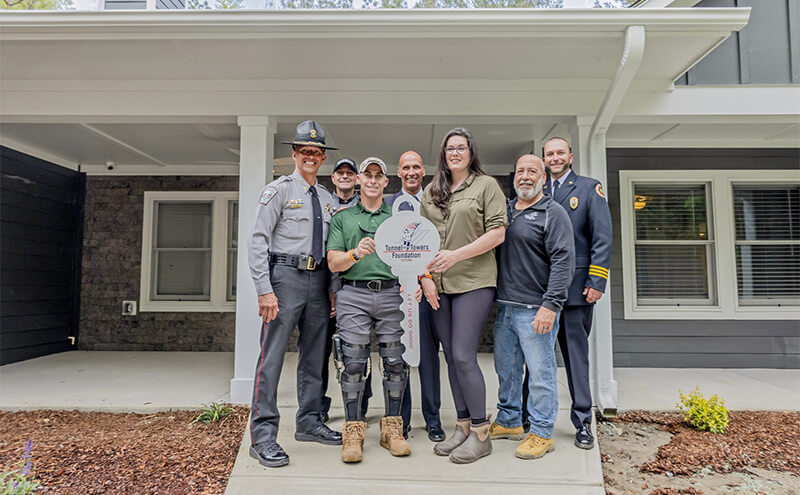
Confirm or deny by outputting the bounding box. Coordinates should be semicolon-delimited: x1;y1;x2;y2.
606;149;800;368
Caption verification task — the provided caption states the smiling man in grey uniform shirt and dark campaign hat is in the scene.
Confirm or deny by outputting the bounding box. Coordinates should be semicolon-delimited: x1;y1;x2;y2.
248;120;342;467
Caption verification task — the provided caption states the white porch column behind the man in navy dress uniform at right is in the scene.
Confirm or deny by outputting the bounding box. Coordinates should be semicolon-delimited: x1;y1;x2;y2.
569;116;618;414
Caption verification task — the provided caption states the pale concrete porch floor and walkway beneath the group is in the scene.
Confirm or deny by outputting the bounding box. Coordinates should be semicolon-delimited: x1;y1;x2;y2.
0;351;800;495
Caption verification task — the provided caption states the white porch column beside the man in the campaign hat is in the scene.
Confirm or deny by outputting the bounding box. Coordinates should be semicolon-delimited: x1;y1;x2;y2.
231;117;276;404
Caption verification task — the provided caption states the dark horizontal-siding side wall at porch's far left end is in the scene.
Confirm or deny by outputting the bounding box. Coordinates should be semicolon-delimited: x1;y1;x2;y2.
0;148;84;364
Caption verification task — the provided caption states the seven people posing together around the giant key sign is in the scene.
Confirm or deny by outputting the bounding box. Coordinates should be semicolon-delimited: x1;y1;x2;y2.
248;121;611;467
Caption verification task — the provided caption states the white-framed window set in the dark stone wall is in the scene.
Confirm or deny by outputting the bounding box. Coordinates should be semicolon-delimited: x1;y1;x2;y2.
140;192;238;311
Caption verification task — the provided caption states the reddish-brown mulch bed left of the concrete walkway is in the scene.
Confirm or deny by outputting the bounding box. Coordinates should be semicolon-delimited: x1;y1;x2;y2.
0;406;248;494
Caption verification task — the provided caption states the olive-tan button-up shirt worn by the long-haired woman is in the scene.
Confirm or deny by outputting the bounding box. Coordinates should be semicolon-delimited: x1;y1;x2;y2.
421;175;508;294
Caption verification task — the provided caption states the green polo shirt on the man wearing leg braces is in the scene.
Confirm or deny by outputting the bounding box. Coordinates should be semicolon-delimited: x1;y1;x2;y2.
328;200;397;281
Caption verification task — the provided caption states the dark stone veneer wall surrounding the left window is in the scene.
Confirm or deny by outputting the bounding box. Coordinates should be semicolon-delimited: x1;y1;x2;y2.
78;176;239;351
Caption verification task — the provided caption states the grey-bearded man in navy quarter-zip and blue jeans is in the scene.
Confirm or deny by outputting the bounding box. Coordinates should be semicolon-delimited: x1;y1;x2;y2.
489;155;575;459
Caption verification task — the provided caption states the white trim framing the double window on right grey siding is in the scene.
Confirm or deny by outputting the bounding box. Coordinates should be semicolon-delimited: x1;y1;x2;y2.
619;169;800;320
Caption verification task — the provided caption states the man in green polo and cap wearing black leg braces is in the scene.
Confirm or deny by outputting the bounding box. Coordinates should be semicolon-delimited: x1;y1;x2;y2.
328;157;411;462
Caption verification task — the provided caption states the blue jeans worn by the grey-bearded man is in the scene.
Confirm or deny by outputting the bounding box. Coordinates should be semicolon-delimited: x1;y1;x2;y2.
494;302;558;438
